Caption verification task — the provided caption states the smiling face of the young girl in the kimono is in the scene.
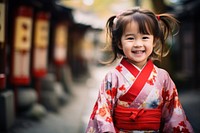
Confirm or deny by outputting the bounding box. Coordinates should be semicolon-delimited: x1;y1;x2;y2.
119;21;154;68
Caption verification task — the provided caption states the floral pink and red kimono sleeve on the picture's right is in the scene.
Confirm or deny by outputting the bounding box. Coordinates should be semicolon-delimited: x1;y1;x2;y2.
162;71;193;133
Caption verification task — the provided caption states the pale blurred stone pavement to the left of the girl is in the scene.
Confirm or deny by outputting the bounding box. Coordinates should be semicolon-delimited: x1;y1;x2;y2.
0;65;112;133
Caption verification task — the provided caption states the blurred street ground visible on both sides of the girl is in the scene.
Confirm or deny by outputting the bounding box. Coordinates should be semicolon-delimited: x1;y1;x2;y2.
1;66;200;133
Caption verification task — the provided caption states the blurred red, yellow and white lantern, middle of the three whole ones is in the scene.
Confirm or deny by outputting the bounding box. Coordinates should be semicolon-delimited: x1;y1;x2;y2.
33;12;50;77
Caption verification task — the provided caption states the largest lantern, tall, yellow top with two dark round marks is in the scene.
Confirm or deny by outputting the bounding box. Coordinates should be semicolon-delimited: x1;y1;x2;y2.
11;6;33;85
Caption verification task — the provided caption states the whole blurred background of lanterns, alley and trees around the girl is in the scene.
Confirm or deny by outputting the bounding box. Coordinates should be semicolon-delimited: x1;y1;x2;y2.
0;0;200;133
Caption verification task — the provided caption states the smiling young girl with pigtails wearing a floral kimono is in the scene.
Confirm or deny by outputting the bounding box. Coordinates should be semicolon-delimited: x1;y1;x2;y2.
86;8;193;133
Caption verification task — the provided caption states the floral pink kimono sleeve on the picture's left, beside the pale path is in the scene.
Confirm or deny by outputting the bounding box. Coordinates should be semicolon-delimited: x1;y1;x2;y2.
86;72;118;133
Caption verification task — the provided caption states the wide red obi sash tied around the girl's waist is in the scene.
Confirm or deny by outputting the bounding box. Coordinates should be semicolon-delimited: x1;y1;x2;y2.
114;105;161;131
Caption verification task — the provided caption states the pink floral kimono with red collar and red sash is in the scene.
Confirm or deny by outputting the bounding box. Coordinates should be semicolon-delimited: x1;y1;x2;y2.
86;58;193;133
